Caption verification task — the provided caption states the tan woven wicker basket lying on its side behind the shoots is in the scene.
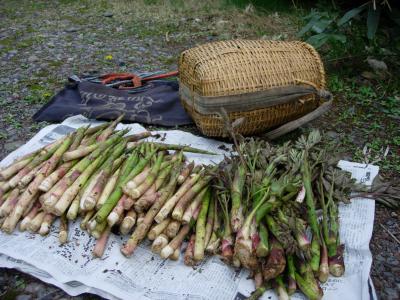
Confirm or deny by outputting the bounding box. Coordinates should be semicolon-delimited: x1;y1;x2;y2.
179;40;325;136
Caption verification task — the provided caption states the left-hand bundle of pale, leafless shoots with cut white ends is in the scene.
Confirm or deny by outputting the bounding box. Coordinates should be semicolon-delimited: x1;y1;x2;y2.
0;118;216;259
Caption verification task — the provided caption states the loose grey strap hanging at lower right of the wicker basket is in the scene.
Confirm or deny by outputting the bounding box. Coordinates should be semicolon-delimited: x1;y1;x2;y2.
265;90;333;140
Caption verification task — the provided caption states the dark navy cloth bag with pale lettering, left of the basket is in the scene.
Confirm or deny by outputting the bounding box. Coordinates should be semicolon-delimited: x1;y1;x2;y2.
33;80;193;126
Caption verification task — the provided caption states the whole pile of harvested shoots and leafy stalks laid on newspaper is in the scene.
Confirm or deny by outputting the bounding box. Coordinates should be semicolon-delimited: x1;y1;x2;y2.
0;118;349;299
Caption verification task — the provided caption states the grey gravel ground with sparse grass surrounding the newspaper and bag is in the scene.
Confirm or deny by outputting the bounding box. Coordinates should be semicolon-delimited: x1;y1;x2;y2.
0;0;400;300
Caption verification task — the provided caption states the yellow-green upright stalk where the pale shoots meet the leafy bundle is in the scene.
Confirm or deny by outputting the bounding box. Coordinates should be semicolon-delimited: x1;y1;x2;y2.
193;190;211;261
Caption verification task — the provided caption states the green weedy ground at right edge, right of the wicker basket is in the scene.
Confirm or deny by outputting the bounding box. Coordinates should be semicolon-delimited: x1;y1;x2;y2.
328;74;400;175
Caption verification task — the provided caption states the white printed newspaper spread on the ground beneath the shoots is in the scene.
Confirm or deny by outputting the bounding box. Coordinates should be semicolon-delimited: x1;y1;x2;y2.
0;116;378;300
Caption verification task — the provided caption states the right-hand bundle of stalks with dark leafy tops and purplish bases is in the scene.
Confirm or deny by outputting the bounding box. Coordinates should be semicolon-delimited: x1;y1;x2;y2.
215;131;352;299
